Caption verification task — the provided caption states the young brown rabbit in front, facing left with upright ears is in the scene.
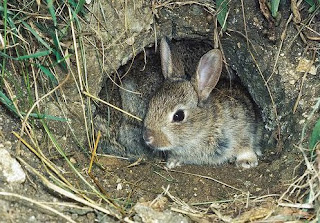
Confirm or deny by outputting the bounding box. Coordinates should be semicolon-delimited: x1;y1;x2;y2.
142;38;262;169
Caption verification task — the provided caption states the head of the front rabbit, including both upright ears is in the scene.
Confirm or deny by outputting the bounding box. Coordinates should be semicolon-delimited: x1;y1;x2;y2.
143;39;222;151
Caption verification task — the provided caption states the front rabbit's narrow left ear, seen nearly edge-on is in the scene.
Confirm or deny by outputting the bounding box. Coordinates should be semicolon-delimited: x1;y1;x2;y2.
160;37;173;79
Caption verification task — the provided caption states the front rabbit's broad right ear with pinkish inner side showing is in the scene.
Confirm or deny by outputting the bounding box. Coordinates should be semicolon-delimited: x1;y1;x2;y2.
195;49;222;102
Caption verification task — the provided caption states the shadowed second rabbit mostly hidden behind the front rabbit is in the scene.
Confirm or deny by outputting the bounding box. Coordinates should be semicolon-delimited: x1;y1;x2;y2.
94;40;212;160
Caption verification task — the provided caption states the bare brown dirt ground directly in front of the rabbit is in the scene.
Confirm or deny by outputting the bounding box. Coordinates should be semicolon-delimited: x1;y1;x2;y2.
91;151;300;204
